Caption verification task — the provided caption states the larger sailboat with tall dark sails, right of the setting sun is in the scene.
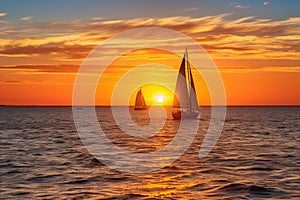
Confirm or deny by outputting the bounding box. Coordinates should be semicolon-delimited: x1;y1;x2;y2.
172;49;200;120
